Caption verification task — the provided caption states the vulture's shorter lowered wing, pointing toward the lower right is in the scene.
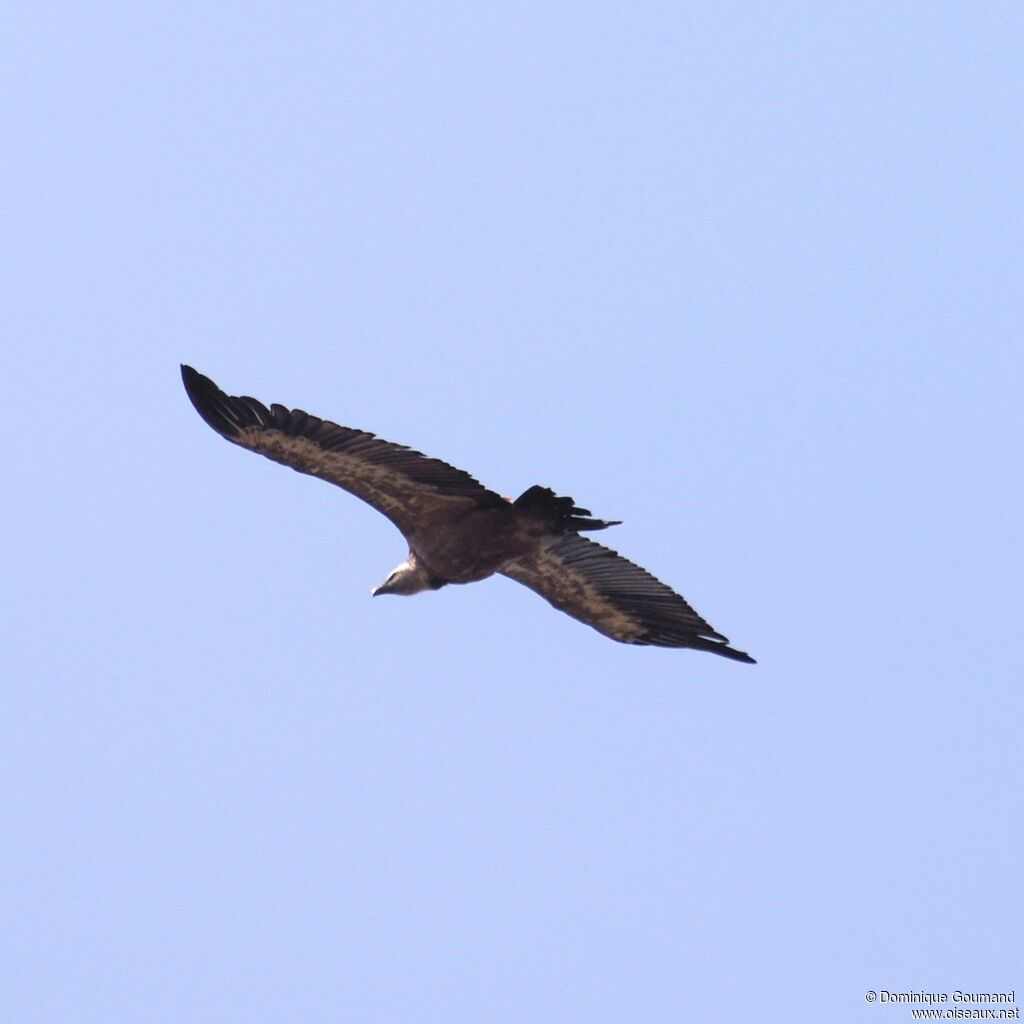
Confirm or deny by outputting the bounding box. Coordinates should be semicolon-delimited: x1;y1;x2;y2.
501;535;754;663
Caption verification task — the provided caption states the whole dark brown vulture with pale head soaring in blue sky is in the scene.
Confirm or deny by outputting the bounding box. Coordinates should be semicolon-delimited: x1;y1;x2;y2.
181;366;754;663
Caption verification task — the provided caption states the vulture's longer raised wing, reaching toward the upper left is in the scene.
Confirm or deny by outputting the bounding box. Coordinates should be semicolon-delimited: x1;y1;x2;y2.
181;366;508;537
